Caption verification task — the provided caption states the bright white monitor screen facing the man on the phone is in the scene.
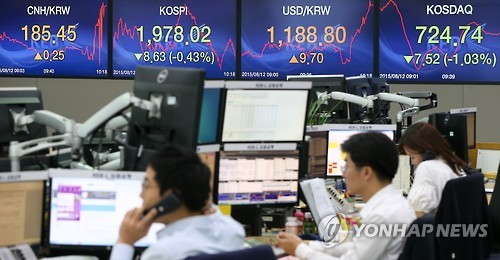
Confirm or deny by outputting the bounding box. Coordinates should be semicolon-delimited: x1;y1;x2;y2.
49;170;163;247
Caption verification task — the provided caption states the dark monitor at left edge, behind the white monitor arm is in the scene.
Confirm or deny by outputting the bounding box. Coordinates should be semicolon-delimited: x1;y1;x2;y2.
0;87;47;157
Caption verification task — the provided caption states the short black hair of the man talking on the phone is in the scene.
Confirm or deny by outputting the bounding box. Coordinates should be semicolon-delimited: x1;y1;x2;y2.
149;145;210;211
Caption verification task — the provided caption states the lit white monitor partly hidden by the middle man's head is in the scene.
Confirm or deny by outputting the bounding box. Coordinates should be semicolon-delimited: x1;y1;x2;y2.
322;124;396;176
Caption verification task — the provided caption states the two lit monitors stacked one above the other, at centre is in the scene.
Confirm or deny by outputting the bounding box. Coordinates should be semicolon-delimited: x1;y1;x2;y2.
216;81;311;205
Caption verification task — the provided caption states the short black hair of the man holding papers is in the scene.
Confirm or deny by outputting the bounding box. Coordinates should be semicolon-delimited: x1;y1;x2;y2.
341;131;399;182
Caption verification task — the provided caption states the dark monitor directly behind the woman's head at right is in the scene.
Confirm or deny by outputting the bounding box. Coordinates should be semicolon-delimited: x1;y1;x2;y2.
429;112;469;162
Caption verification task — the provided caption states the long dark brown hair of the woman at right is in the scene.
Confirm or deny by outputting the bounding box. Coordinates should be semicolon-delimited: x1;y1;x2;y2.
399;122;467;175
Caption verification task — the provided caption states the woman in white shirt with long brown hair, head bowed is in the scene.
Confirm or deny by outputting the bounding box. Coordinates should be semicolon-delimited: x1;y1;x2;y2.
399;122;466;217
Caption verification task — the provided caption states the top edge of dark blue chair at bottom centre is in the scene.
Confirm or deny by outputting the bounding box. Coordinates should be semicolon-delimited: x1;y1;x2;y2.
185;245;276;260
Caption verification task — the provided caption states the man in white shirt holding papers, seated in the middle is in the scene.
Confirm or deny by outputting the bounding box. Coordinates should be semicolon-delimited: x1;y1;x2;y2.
277;132;416;260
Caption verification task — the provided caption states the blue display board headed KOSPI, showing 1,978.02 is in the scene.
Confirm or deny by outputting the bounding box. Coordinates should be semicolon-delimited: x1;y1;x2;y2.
112;0;237;79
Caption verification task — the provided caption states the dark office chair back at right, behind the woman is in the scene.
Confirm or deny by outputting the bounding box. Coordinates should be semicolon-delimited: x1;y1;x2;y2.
435;174;490;259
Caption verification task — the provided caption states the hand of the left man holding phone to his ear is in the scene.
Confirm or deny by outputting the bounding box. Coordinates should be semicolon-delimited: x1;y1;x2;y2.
118;208;158;246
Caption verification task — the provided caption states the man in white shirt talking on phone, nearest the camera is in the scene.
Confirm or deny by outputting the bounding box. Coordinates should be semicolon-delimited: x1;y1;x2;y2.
110;145;245;260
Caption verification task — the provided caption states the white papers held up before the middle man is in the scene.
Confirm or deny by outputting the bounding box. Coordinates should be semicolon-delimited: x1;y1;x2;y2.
300;178;336;225
